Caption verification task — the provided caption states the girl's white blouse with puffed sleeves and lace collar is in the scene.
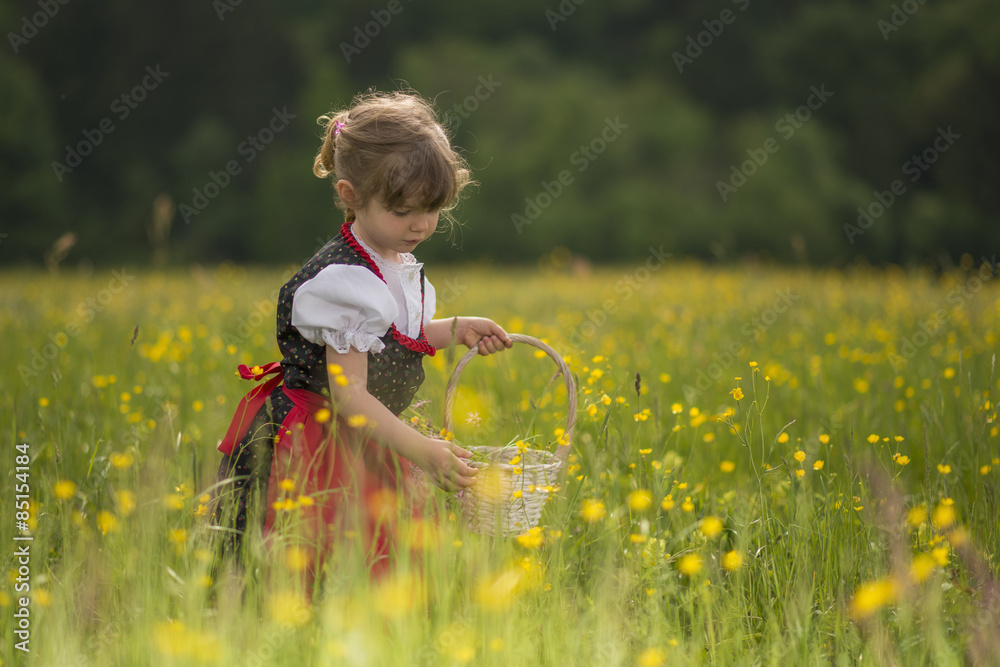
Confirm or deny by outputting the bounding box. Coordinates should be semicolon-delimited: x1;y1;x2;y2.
292;237;437;354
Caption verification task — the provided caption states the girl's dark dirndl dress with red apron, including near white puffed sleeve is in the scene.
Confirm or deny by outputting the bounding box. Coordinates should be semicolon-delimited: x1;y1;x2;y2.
214;223;435;571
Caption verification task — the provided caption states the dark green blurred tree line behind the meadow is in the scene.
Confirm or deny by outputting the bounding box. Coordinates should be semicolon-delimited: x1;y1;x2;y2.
0;0;1000;266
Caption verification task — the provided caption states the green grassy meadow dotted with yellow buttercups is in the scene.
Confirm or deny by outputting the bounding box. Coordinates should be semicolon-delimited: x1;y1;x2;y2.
0;251;1000;667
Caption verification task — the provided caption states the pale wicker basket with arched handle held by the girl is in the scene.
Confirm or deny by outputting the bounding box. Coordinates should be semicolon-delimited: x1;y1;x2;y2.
444;334;576;537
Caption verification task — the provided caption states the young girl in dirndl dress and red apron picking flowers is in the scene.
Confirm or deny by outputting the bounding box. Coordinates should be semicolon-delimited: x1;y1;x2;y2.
216;93;511;580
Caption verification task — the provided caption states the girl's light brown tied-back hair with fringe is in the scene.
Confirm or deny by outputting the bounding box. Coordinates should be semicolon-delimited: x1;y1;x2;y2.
313;92;471;222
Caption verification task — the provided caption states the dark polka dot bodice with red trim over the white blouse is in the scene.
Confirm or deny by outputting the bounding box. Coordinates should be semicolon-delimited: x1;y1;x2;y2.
277;224;435;415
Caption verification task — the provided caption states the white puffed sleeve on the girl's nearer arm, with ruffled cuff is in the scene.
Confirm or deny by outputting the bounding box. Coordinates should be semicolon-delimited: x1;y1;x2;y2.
292;264;399;354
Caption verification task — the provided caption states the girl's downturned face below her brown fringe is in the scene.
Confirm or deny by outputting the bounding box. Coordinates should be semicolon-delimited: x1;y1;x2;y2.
338;181;441;263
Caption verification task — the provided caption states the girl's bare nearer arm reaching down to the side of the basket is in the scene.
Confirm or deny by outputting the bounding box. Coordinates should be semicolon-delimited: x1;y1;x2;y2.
326;344;477;491
